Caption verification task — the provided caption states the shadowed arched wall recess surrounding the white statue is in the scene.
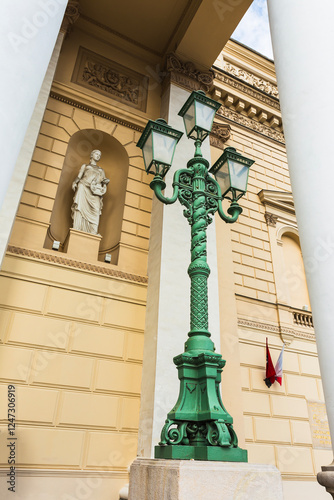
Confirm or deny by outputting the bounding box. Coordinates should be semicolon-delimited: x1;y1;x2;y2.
45;129;129;264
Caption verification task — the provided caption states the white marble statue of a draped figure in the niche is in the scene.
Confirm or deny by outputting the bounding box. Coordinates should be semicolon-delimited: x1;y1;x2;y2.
72;149;109;234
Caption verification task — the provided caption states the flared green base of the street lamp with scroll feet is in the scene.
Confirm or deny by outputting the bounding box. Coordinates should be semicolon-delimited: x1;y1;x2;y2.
155;351;247;462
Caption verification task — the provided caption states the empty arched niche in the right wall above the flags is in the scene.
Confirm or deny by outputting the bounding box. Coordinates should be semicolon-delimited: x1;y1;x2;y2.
278;227;311;310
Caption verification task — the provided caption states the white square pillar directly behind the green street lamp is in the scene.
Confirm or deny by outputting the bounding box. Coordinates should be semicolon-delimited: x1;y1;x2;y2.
138;85;220;458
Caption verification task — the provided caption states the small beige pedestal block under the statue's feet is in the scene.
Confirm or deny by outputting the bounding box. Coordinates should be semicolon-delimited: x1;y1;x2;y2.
64;228;102;262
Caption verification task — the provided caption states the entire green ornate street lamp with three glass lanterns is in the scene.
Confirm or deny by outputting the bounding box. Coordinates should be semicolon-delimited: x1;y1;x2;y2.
137;91;254;462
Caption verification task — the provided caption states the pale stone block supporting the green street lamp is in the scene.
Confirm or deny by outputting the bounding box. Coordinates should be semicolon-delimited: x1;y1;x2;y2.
129;458;283;500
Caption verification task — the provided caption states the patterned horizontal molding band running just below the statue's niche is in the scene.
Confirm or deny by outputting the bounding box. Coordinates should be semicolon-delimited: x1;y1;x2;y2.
7;245;148;284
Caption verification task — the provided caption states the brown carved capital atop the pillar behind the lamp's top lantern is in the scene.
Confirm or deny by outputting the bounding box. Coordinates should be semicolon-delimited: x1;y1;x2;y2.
163;53;214;92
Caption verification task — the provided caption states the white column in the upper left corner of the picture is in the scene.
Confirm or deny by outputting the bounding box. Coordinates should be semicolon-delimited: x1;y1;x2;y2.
0;0;67;264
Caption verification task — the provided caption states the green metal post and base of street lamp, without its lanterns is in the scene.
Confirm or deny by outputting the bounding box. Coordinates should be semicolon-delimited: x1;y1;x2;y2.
151;151;247;462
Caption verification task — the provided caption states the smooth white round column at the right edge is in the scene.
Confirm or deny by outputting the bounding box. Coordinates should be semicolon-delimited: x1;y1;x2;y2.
268;0;334;460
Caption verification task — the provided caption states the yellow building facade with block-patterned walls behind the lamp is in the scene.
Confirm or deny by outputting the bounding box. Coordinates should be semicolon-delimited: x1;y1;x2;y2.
0;2;332;500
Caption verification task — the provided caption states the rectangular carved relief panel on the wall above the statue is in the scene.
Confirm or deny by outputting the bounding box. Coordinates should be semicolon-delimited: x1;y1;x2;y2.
72;47;148;111
